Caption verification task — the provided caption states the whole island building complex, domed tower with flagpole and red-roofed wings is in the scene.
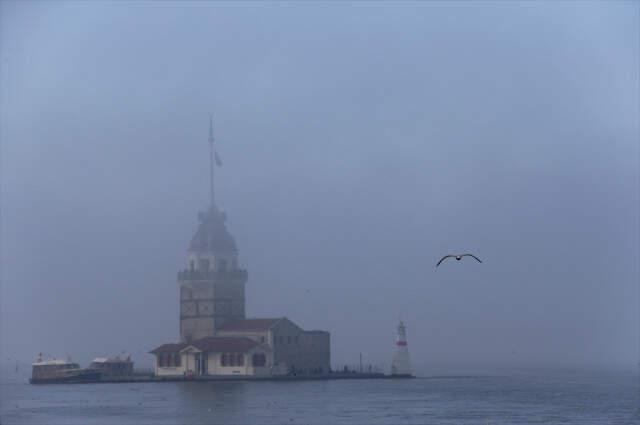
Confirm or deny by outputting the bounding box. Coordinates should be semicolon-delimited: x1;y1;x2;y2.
151;120;331;376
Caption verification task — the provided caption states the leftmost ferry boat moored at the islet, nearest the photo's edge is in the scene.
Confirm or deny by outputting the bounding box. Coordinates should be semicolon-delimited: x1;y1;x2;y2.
29;358;102;384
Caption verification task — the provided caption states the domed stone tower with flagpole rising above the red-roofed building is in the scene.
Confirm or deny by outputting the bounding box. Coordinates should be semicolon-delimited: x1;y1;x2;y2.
178;117;248;342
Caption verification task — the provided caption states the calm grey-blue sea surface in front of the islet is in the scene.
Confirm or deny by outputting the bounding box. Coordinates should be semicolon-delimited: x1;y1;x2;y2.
0;372;640;425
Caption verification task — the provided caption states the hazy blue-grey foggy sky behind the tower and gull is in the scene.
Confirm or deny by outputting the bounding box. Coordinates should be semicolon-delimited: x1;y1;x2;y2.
0;1;640;374
